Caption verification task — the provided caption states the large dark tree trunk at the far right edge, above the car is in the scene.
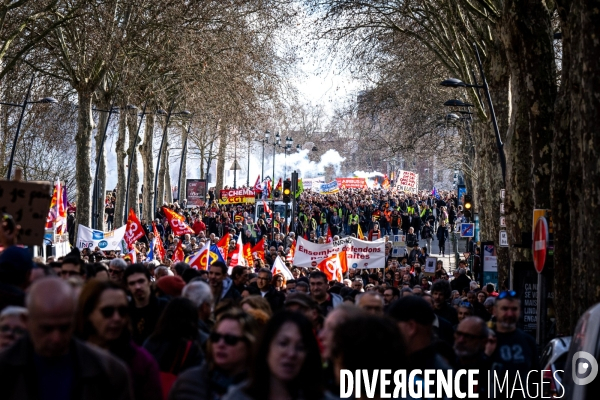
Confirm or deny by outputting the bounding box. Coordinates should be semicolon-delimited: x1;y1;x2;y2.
565;0;600;324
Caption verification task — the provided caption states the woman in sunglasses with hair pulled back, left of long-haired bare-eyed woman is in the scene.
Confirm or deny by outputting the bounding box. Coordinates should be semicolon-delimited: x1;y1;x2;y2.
169;309;258;400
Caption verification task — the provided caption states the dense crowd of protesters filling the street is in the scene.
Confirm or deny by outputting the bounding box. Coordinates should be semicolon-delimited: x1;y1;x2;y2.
0;186;539;400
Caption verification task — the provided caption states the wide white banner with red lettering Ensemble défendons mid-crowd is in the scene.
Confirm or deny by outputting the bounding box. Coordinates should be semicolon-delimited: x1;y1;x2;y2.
294;237;385;269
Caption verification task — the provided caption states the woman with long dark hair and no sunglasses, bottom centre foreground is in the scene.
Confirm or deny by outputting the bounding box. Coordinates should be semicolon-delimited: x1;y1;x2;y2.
224;311;324;400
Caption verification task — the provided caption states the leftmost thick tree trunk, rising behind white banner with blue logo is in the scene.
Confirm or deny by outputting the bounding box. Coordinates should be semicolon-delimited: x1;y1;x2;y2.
75;90;94;231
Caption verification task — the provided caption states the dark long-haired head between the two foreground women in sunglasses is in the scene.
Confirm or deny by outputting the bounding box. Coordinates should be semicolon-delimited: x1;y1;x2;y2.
144;297;204;398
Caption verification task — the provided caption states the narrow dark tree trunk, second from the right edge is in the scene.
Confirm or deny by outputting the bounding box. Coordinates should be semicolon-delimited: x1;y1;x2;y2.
550;0;576;335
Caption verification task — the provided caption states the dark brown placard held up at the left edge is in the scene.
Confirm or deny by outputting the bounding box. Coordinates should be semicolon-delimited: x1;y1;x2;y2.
0;181;52;246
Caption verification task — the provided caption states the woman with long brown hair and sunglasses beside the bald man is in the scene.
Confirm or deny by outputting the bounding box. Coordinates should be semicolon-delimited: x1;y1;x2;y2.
76;279;163;400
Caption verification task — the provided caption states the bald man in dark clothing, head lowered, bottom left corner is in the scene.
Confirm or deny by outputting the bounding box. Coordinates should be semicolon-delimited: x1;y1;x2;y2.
0;277;132;400
